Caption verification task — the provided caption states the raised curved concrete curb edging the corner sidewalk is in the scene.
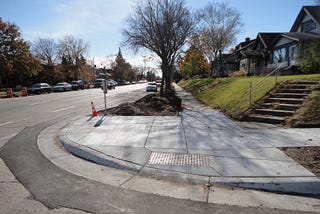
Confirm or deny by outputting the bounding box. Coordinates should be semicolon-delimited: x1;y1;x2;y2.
58;129;320;197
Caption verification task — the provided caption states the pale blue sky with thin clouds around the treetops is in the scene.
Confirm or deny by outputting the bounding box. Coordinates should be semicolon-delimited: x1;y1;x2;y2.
0;0;315;67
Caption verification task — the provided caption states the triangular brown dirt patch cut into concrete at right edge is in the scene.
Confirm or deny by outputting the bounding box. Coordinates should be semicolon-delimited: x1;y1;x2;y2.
280;146;320;177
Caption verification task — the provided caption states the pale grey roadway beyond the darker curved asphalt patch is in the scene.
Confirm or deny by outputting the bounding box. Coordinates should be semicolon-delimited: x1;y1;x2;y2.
0;84;146;146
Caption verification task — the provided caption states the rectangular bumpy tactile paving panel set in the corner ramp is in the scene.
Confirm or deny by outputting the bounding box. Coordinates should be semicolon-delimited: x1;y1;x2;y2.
148;152;213;167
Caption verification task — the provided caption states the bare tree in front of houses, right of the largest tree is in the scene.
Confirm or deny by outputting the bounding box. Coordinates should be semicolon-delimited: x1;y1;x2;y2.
197;3;242;76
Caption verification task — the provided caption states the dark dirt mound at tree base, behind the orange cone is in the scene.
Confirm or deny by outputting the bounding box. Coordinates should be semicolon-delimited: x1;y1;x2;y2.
99;94;182;116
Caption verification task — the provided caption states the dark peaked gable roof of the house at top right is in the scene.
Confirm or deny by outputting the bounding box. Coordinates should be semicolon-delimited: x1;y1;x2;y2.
290;6;320;32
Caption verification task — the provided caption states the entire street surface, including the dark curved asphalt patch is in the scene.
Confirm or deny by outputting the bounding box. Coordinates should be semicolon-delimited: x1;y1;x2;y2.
0;85;316;214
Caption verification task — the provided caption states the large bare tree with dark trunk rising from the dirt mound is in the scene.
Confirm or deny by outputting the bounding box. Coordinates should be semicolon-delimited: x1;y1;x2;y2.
123;0;194;95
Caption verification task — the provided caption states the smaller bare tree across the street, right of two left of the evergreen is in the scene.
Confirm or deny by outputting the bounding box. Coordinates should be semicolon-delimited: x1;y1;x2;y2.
58;35;89;80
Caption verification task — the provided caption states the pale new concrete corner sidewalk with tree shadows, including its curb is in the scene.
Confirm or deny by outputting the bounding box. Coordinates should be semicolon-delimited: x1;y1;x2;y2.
59;87;320;194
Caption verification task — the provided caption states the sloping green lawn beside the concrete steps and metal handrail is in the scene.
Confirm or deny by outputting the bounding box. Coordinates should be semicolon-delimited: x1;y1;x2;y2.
179;74;320;118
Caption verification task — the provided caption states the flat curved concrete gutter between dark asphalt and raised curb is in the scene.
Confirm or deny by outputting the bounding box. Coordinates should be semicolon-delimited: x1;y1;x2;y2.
38;118;319;212
